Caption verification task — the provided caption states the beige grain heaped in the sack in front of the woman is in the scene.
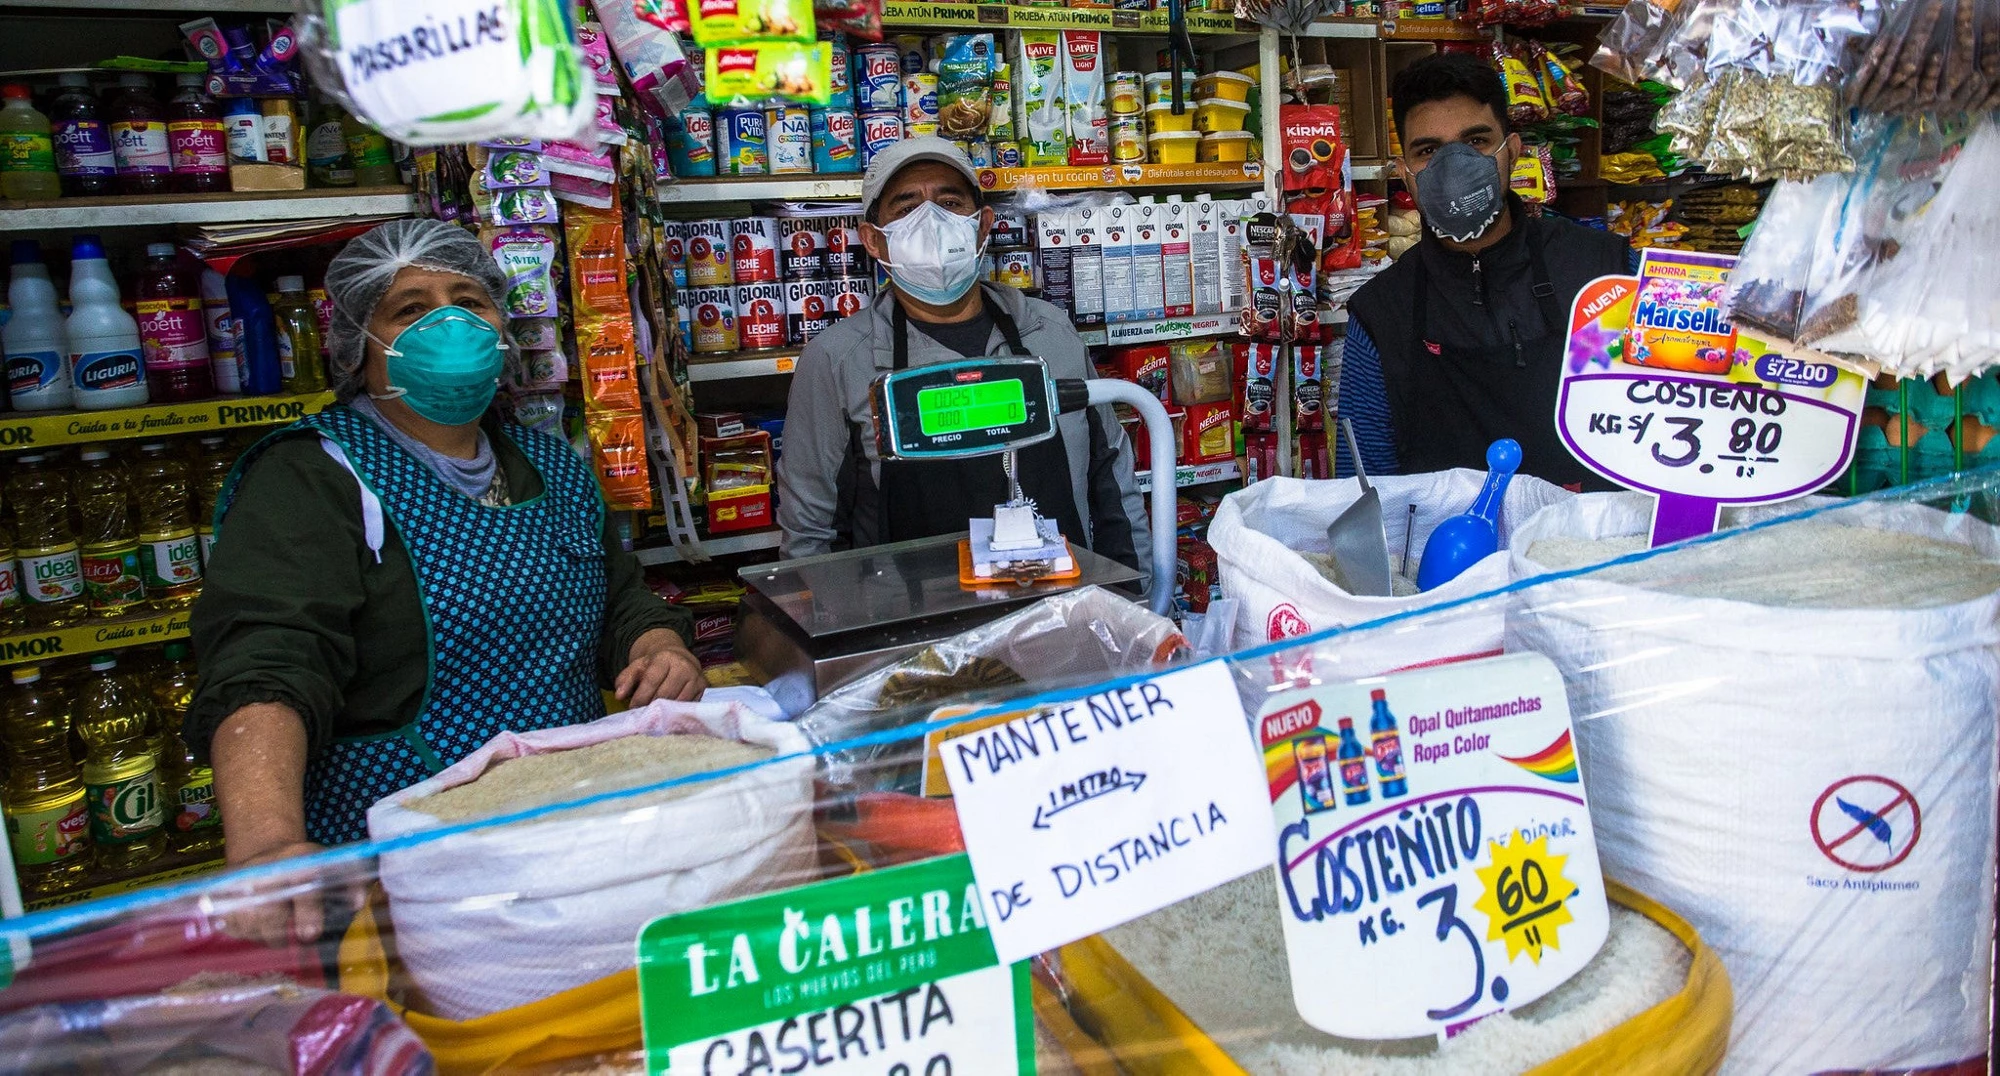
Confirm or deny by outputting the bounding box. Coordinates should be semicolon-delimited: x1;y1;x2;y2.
406;734;772;822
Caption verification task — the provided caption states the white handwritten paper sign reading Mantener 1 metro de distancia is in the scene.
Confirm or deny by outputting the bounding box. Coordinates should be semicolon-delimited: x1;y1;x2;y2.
938;662;1270;960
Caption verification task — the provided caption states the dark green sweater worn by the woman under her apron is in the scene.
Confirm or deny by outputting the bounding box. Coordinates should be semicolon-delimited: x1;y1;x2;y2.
186;418;692;758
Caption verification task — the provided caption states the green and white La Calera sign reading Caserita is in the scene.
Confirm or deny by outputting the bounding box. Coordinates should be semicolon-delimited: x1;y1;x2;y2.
638;856;1034;1076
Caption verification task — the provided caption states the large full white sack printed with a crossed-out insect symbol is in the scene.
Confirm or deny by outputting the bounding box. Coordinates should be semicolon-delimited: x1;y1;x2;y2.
1508;494;2000;1072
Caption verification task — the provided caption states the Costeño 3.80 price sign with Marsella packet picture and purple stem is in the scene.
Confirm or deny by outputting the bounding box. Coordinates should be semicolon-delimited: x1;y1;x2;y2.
1556;250;1868;546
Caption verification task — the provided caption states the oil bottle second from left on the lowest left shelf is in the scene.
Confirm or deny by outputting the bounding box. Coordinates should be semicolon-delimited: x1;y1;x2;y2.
76;654;166;870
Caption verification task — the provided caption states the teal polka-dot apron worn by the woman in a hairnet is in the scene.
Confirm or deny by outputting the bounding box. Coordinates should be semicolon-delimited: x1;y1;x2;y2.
216;406;608;844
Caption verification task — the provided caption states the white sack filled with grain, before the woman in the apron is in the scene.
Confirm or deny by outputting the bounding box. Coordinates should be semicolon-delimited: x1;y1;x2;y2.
368;702;814;1020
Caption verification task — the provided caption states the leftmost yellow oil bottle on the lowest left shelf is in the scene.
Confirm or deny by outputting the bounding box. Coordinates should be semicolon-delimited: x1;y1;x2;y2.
0;666;90;896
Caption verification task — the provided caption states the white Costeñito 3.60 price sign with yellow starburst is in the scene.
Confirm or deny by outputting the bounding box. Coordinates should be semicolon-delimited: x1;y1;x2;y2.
1256;654;1610;1038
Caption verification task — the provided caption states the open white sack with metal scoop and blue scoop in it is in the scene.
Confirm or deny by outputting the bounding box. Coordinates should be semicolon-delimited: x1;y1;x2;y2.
1208;468;1572;676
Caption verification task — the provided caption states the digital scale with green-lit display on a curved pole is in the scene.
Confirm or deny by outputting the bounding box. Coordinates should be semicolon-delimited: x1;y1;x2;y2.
736;356;1174;714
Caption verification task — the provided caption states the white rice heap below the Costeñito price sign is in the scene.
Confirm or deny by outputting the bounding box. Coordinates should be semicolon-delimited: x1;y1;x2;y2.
1106;870;1690;1076
